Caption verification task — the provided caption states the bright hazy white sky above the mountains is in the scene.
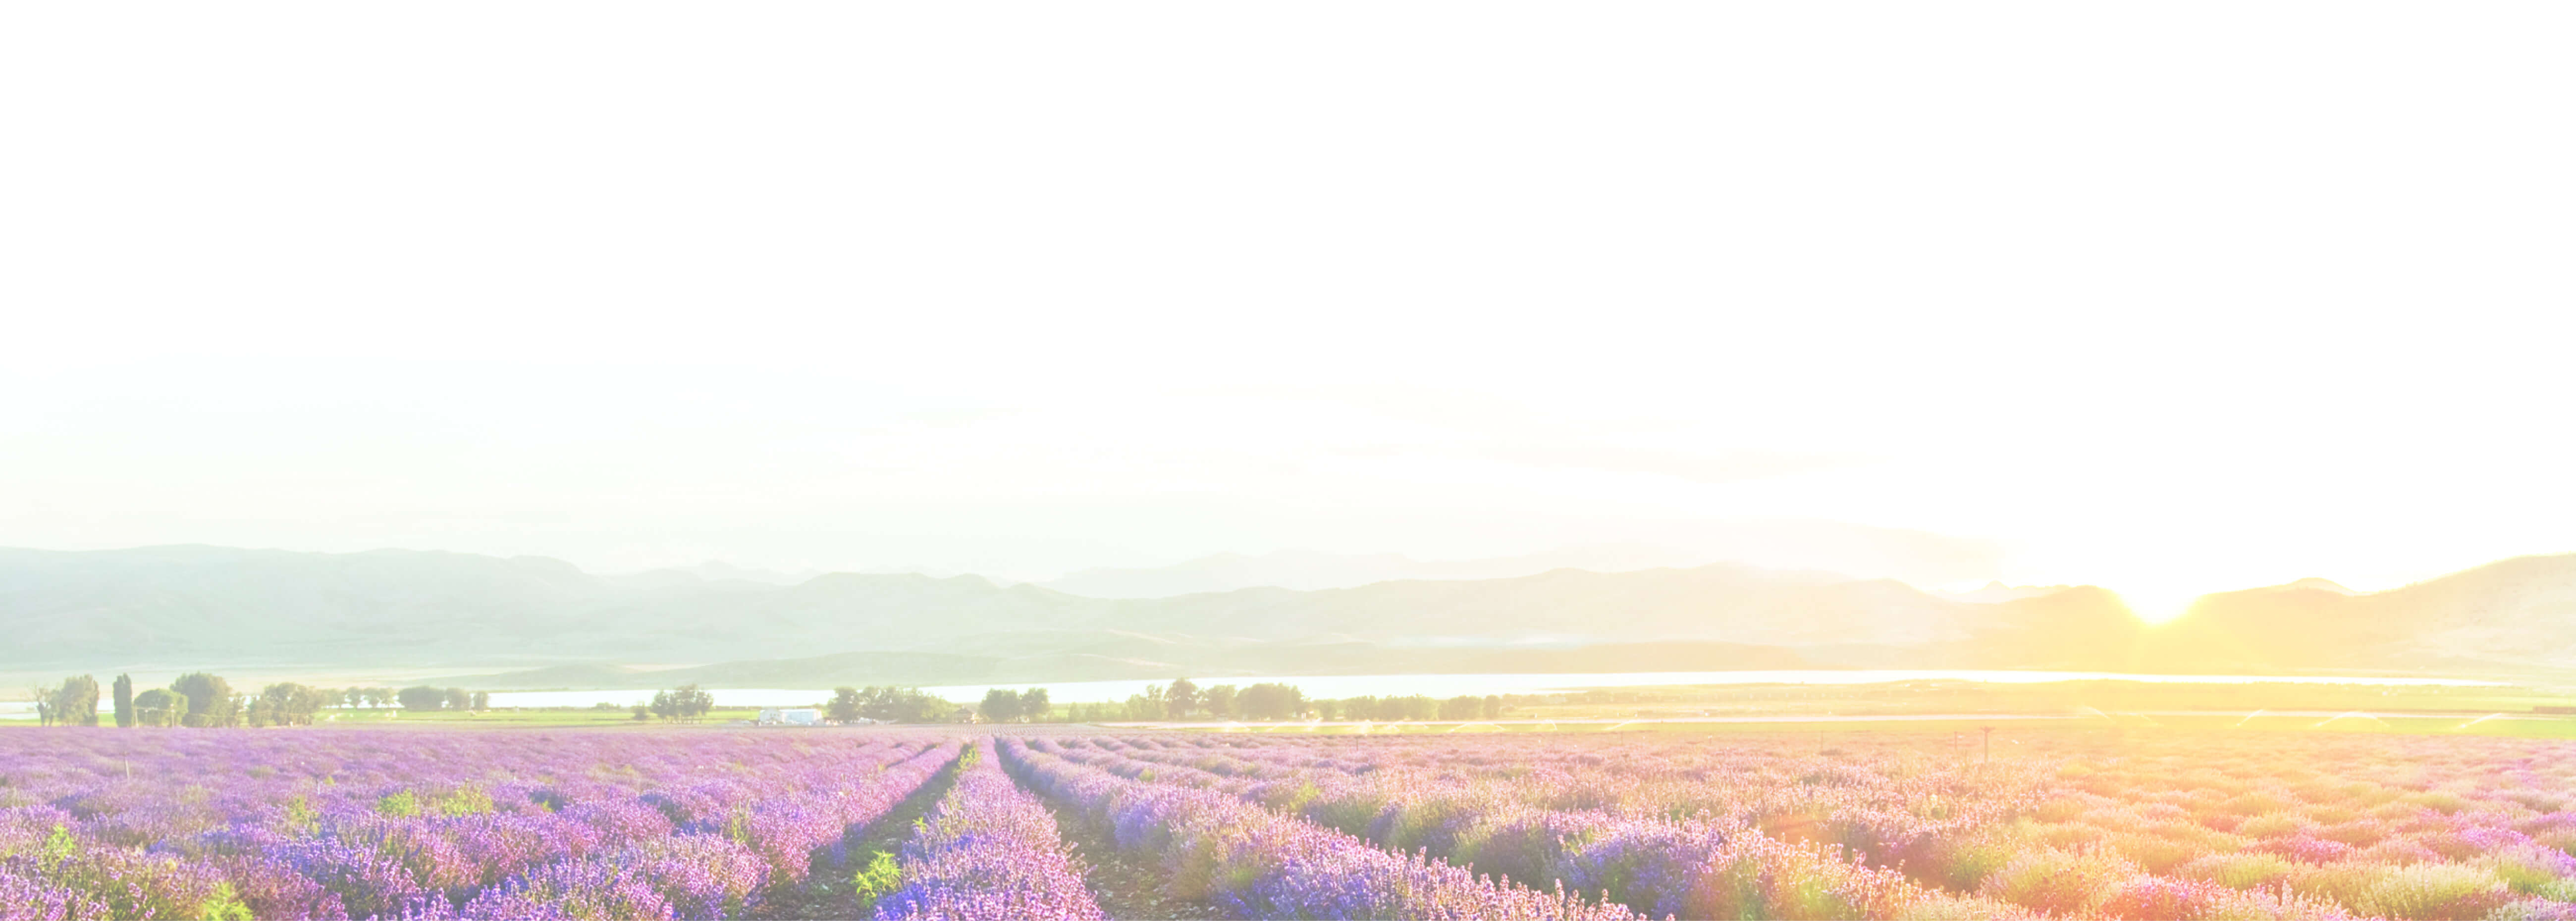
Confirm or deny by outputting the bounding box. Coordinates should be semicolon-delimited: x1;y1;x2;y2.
0;2;2576;612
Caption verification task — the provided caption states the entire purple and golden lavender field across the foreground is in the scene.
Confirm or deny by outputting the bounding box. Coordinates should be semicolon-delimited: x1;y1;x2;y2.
0;728;2576;919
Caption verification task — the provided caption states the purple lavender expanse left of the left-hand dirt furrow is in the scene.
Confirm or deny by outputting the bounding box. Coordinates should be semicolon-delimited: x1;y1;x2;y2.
0;731;956;921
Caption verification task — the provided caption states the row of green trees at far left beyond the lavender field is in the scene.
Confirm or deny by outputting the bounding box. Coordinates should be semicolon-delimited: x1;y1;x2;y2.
28;671;492;728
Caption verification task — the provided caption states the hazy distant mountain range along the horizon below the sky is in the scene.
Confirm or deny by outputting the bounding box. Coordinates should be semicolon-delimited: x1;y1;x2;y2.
0;545;2576;687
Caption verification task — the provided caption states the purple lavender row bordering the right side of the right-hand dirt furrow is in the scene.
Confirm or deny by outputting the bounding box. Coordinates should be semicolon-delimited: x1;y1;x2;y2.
1000;738;1636;919
